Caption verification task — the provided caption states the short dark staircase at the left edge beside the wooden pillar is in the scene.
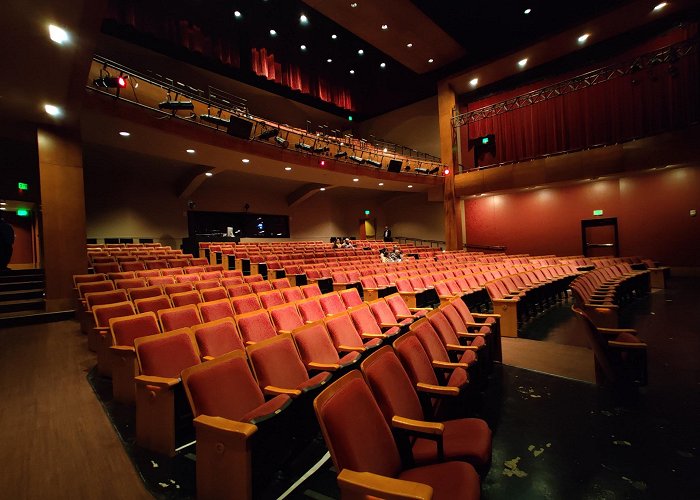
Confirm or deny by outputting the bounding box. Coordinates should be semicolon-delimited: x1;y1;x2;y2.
0;269;75;328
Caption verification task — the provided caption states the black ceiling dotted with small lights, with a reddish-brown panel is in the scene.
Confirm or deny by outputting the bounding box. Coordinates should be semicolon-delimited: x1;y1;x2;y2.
97;0;693;119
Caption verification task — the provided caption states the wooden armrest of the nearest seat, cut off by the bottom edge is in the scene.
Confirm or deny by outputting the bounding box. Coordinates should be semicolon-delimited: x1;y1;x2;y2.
338;469;433;500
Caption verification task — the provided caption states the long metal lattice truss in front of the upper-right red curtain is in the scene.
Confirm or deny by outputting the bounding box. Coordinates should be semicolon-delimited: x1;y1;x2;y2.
452;37;698;128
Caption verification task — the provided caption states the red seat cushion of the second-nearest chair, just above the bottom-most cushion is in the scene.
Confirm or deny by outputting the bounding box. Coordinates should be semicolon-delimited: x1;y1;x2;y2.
413;418;491;467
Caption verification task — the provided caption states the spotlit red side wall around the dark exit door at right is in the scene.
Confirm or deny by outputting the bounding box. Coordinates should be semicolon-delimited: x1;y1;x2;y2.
464;167;700;266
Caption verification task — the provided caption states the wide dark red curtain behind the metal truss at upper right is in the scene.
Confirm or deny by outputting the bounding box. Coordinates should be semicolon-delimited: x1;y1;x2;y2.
460;28;700;166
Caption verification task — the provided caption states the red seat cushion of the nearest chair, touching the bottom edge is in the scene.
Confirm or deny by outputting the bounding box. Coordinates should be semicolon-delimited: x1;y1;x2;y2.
399;462;481;500
